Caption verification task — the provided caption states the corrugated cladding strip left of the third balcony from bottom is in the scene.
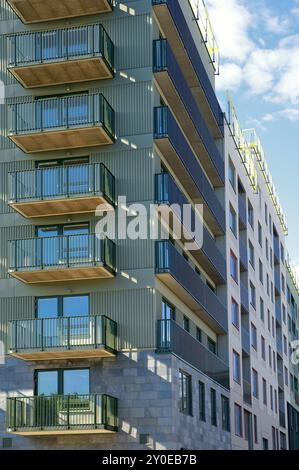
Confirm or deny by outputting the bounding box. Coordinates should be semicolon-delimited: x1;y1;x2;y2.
0;225;34;279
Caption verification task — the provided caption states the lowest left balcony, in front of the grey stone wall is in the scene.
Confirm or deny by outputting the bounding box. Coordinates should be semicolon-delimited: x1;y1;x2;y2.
6;394;118;436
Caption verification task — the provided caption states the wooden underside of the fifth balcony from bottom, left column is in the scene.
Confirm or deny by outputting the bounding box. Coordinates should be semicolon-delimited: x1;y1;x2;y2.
9;126;113;153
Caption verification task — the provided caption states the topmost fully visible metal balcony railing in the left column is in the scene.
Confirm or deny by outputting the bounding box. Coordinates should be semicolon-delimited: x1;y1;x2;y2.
7;24;114;72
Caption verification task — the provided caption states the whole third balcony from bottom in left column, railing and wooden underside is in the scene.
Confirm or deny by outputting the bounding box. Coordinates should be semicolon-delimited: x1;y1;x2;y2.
9;234;116;284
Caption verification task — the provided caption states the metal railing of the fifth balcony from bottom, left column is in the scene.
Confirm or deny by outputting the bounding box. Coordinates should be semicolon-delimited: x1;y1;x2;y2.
8;93;115;139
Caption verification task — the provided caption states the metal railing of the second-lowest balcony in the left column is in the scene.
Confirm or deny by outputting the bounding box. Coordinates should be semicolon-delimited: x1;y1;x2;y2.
9;315;117;354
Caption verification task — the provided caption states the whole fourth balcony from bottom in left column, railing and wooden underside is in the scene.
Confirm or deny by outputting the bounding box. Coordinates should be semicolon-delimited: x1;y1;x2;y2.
9;163;116;219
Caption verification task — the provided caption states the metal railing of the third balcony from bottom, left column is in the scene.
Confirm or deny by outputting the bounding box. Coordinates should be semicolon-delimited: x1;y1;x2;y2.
9;234;116;273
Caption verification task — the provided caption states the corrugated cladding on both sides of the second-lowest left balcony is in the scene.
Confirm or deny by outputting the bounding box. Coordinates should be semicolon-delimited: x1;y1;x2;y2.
0;289;156;351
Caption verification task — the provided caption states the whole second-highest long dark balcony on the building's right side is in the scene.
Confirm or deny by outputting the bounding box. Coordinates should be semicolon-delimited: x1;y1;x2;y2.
153;39;224;187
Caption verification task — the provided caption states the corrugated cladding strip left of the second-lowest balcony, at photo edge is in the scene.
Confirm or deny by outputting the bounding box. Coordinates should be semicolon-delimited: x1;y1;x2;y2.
0;297;34;352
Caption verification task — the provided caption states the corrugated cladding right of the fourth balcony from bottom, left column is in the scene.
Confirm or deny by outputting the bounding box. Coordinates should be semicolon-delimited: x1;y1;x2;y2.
91;148;154;202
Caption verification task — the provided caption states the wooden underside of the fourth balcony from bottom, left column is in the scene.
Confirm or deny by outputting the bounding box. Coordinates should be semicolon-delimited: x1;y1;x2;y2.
10;196;114;219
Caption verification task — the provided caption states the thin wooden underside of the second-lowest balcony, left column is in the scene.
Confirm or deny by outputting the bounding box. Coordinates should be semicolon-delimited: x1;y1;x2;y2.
10;346;116;361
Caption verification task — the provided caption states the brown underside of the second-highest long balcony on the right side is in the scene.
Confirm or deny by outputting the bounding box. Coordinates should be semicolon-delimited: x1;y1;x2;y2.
154;71;223;187
